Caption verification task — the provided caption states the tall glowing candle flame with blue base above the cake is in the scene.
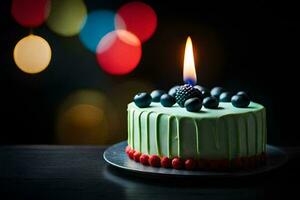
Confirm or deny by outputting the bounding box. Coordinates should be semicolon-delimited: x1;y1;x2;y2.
183;36;197;85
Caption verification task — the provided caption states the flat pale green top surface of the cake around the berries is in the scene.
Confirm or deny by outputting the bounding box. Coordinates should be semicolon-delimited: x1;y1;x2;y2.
128;102;264;118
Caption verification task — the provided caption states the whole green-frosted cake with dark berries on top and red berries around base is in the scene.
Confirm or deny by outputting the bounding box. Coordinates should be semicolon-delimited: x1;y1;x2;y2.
125;84;267;170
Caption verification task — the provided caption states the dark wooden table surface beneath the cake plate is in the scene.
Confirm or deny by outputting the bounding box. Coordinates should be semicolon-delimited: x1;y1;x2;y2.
0;145;300;200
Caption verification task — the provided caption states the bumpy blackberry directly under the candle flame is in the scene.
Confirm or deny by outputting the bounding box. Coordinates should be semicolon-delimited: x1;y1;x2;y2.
175;84;202;107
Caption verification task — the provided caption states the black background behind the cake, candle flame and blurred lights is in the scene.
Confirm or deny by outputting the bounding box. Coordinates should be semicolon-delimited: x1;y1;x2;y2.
0;0;300;145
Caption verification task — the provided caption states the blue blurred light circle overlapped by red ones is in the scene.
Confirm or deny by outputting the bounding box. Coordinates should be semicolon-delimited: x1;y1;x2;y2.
79;10;124;53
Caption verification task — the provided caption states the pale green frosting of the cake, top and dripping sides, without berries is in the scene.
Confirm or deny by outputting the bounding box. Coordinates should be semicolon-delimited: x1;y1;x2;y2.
127;102;267;170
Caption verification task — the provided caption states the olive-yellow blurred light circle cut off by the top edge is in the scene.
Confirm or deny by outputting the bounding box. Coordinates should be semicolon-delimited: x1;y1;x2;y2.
47;0;87;36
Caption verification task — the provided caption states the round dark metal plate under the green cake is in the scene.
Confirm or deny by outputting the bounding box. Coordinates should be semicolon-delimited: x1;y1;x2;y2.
103;141;288;177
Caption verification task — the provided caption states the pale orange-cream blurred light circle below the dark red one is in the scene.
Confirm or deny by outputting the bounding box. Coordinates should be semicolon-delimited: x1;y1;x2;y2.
14;34;51;74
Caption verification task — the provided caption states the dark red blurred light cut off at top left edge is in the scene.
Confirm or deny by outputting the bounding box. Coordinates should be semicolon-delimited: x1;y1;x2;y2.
11;0;50;27
